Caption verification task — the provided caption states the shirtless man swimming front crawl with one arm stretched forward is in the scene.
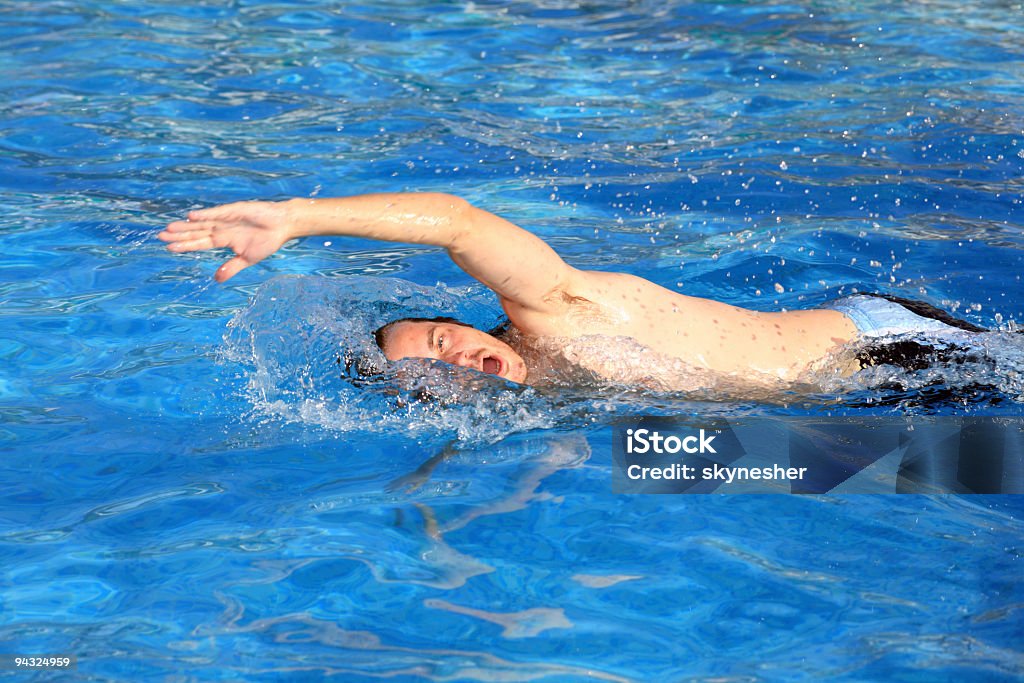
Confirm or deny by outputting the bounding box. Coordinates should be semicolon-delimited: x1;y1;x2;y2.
160;194;1024;397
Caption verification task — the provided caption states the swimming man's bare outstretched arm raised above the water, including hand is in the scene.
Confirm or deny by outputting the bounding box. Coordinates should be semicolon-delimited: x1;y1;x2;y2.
158;193;578;311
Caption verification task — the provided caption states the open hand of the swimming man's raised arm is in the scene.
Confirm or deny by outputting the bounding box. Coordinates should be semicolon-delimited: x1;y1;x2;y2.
157;202;294;283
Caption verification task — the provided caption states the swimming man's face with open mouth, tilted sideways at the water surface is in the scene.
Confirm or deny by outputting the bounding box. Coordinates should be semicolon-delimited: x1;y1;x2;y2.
374;317;526;384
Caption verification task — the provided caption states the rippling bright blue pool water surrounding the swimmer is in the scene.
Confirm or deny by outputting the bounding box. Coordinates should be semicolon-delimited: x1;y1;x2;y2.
0;0;1024;681
